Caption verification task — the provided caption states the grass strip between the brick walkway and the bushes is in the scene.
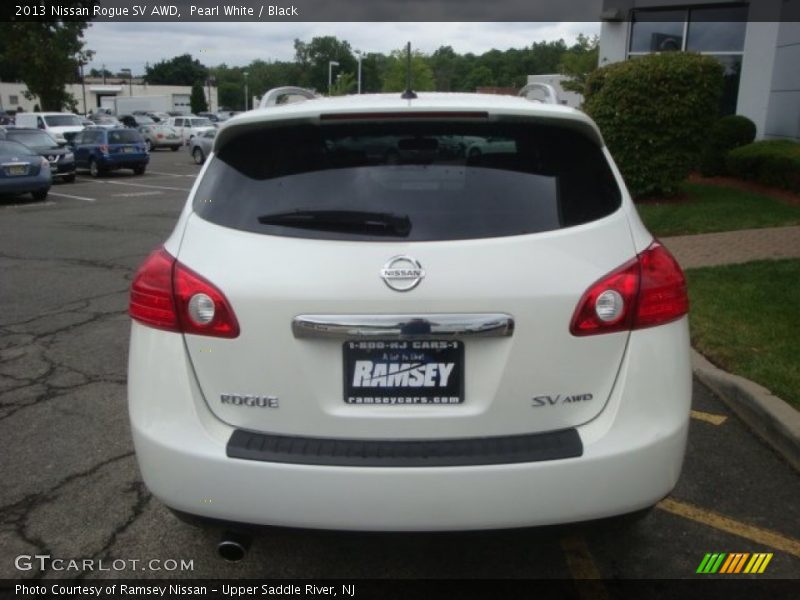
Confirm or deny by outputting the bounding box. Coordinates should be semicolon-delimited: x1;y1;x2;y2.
636;183;800;237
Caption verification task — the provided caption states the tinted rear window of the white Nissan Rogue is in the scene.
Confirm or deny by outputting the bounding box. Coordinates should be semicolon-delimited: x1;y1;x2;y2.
194;121;620;241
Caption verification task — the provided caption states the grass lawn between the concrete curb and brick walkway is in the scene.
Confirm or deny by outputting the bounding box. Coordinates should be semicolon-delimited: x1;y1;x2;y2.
686;259;800;409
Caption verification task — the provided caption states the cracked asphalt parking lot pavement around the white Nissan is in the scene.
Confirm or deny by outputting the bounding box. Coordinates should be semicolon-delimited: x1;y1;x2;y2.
0;151;800;579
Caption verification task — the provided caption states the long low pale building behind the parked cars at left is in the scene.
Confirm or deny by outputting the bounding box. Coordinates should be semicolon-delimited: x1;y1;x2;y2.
0;77;219;114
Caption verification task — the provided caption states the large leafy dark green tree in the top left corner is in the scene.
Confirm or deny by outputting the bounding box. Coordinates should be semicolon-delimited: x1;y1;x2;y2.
0;0;94;111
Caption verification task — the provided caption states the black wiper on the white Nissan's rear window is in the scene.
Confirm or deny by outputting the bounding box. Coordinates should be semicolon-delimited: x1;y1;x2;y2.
258;210;411;237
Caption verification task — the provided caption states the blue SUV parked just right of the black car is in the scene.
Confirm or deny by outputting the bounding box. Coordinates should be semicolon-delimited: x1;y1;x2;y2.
69;127;150;177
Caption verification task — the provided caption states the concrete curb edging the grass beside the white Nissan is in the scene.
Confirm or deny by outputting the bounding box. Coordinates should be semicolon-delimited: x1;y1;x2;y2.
692;348;800;471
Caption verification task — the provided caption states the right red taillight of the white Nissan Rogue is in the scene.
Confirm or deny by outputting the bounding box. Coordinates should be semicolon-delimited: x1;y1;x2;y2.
570;242;689;335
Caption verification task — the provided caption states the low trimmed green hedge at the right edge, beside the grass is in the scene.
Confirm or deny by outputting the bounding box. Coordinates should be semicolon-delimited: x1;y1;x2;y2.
725;140;800;192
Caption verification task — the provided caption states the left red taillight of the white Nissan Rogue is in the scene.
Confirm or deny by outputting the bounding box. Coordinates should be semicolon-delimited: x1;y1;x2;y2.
129;248;239;338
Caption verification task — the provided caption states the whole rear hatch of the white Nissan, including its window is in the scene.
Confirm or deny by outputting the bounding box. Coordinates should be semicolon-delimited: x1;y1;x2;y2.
177;116;635;439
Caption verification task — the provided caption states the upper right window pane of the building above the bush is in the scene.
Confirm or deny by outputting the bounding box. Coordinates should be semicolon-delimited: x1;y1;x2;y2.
686;7;747;52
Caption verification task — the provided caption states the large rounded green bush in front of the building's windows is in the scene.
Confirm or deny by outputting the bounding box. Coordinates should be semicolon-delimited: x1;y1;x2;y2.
584;52;723;196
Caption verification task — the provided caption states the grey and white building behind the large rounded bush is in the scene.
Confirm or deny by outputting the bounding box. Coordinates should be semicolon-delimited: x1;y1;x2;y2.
599;0;800;139
